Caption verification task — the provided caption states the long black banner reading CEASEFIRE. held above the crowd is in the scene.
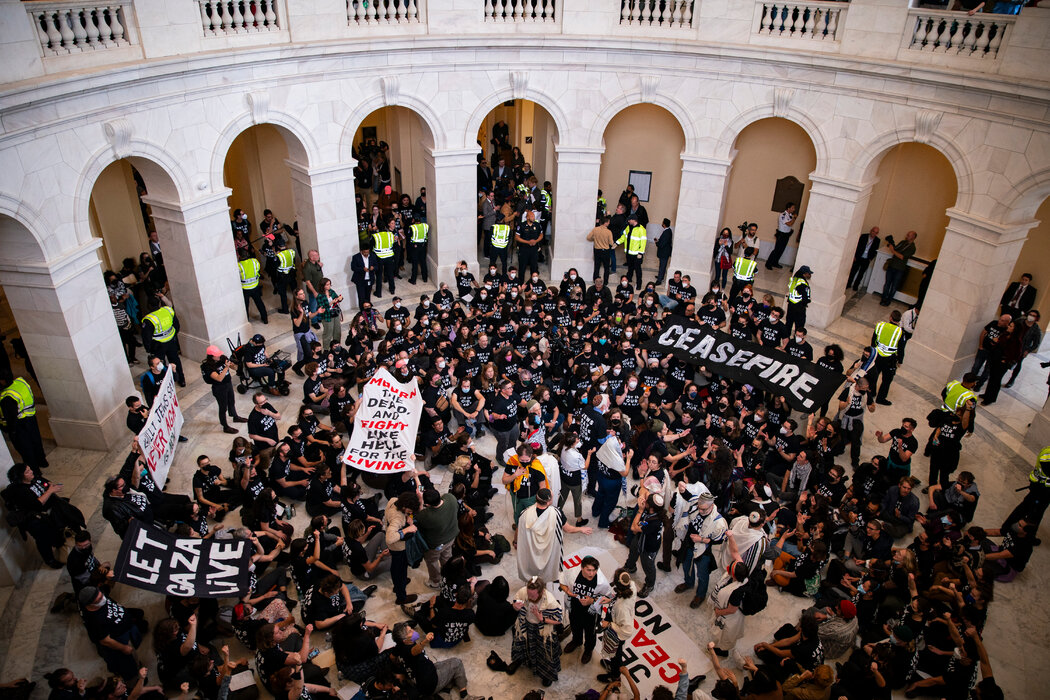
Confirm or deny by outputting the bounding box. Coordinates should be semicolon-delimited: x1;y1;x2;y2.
642;320;845;413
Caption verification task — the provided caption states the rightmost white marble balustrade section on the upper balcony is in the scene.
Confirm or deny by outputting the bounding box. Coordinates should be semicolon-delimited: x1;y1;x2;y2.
907;9;1017;59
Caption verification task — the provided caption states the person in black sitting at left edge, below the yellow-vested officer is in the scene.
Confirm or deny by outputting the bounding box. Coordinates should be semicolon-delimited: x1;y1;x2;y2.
3;463;84;569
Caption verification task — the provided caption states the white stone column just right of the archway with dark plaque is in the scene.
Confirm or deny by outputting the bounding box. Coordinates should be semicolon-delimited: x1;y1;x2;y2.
777;175;875;328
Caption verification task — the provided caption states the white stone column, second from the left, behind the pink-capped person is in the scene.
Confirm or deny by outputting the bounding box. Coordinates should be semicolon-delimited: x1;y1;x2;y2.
143;189;252;363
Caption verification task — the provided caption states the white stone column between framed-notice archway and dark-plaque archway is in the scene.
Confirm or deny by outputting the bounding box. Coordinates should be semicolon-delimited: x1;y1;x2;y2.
667;153;733;297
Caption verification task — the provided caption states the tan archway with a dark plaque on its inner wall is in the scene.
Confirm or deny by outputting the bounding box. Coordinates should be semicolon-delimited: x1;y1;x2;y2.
726;116;817;294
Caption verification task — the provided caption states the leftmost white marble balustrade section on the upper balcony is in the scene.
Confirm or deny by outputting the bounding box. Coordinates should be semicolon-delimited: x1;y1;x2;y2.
26;0;132;56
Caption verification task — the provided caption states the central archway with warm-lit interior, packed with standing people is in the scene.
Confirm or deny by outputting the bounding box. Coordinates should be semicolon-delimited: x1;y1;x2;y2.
478;100;559;276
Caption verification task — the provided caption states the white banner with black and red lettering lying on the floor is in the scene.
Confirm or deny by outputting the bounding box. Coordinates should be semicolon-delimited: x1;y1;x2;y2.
562;547;711;698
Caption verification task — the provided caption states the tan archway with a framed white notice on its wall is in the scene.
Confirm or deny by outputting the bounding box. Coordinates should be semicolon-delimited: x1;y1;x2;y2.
600;104;686;284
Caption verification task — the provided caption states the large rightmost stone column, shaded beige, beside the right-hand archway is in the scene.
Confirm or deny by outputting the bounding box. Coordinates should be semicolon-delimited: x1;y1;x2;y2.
907;210;1036;390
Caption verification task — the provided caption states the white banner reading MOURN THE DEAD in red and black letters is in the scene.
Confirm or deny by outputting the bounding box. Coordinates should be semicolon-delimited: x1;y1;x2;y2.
342;367;423;474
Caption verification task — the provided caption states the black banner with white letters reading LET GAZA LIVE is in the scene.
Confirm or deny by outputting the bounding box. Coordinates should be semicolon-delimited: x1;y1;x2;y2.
113;521;255;598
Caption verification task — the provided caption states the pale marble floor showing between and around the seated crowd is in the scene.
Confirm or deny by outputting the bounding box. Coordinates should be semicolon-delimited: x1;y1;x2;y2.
0;262;1050;700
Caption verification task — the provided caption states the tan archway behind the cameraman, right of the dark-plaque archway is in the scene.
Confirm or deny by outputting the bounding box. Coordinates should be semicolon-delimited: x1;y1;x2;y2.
847;142;959;309
